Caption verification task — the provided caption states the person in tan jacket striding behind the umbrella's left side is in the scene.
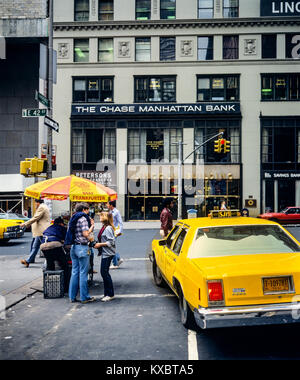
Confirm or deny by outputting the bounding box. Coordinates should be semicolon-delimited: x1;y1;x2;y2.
20;199;50;268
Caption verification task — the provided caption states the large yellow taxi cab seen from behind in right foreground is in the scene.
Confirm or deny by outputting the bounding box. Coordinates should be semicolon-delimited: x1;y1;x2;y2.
150;210;300;329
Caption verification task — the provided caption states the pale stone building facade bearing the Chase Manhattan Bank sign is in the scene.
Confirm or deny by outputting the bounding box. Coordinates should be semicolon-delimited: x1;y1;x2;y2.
54;0;300;220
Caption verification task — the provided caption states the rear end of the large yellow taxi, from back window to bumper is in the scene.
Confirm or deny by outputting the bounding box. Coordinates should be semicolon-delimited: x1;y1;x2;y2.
187;218;300;329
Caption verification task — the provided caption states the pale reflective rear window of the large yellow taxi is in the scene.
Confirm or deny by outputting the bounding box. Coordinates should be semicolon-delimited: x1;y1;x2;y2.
188;225;300;259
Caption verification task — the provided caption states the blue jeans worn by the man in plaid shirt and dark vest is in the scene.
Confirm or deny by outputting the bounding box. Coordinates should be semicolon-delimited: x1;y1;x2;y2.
69;244;90;301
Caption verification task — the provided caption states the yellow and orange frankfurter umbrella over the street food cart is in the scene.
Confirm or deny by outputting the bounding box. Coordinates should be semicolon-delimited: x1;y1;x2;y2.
24;175;117;202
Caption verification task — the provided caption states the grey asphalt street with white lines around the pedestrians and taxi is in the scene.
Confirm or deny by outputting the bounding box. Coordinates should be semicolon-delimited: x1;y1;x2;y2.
0;227;300;361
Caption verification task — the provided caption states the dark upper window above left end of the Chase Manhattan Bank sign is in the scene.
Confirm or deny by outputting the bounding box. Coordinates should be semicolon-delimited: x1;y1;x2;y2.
73;77;113;103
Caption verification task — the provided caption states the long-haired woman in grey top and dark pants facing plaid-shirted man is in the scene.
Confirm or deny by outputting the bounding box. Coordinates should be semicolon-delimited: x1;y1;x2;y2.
94;212;116;302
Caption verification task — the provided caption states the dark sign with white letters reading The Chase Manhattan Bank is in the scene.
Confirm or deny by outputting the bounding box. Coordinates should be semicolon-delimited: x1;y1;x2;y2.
72;103;240;116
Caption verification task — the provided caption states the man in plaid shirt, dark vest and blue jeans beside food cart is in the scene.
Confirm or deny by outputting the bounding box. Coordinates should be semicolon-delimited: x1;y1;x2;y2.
65;203;96;303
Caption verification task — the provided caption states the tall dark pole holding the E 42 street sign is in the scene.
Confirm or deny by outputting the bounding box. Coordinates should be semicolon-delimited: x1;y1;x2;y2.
47;0;53;179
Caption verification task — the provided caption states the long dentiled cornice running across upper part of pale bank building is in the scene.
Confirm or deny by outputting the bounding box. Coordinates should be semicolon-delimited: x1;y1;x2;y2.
54;17;300;31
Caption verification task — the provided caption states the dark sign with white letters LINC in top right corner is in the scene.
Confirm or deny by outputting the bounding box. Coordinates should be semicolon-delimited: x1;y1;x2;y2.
260;0;300;17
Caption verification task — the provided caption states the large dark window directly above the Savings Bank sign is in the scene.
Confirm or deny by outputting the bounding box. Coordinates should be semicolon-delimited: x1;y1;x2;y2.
261;117;300;170
